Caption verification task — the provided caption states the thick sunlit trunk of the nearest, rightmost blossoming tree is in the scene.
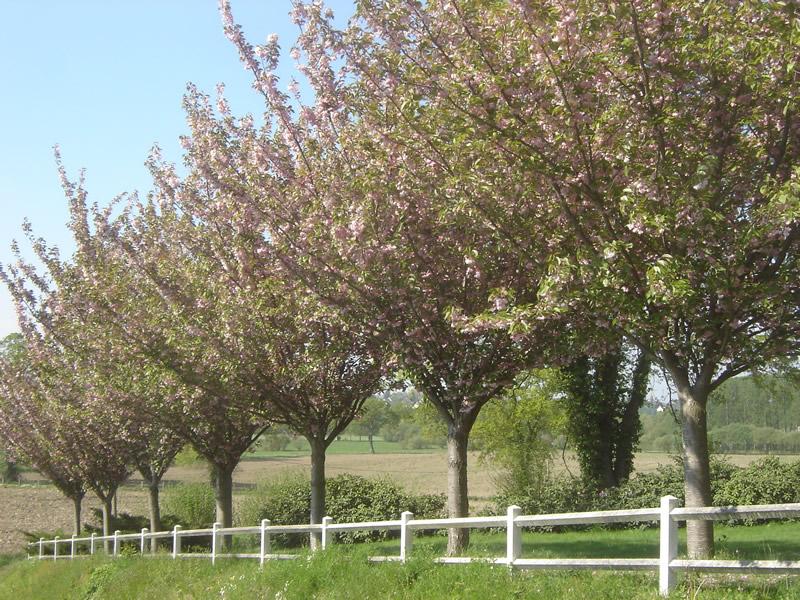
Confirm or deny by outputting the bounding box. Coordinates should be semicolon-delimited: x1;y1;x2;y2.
678;386;714;558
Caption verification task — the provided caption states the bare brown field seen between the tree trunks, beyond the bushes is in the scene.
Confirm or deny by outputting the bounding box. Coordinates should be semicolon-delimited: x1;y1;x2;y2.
0;452;800;554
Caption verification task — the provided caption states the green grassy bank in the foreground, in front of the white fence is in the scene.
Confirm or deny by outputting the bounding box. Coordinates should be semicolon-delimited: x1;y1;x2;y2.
0;548;800;600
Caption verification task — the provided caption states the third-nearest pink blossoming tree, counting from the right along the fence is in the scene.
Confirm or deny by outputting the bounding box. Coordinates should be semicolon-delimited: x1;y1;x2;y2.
120;129;389;540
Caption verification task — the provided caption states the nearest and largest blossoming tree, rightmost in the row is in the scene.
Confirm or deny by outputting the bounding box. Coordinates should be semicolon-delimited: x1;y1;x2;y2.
316;0;800;556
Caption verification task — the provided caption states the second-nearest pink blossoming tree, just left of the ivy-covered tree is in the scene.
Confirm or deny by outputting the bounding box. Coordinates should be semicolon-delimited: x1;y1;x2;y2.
216;2;551;553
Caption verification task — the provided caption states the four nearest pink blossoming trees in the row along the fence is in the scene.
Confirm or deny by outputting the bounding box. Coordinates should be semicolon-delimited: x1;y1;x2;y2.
5;0;800;556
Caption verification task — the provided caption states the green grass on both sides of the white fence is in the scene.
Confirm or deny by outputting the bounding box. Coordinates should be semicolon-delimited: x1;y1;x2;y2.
0;523;800;600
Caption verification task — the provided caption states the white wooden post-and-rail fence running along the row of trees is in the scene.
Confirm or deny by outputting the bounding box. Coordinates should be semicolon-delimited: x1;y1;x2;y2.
29;496;800;595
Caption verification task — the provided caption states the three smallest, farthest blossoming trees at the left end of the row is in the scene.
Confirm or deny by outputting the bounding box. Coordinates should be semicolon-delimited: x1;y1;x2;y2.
0;332;183;548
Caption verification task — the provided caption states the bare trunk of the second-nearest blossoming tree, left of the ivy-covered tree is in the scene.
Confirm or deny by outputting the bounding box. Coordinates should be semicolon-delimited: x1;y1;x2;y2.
447;423;469;556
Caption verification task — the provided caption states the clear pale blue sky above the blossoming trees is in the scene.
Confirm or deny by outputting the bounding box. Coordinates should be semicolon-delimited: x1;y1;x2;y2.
0;0;353;336
